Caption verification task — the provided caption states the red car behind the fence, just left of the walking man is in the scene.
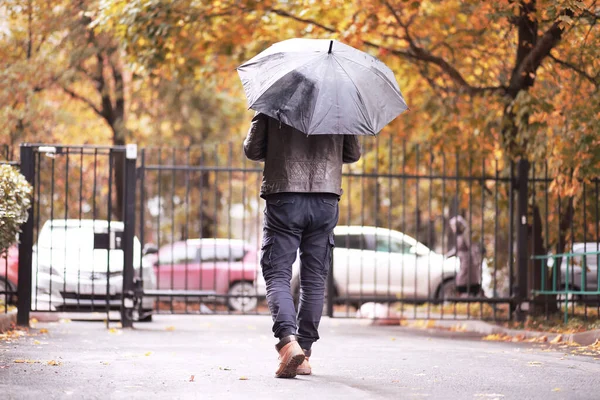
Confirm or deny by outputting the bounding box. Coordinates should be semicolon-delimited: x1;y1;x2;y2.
153;238;258;311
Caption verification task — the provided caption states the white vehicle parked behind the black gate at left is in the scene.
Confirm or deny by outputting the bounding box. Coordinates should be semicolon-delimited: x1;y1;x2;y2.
31;219;156;320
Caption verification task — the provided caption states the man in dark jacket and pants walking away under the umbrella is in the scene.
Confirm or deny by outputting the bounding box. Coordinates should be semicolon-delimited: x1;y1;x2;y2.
244;113;361;378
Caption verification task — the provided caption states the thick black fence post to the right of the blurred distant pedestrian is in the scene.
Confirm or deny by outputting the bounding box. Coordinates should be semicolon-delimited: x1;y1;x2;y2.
517;159;529;320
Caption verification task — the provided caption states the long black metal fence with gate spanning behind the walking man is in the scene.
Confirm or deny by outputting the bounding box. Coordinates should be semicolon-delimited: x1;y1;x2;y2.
9;141;600;324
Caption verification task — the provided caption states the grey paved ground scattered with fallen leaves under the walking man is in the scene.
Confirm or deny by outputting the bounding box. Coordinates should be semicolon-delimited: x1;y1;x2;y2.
0;316;600;400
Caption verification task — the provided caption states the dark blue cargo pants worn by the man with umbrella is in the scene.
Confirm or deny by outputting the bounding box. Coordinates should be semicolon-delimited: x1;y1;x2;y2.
260;193;339;350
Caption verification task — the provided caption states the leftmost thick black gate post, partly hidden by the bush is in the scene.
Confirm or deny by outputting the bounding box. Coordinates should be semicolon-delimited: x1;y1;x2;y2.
17;144;35;327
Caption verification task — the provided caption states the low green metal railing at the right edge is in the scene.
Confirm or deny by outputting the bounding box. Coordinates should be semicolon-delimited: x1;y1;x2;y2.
531;251;600;324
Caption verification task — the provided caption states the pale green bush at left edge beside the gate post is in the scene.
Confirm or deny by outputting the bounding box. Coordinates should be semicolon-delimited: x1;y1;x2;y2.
0;164;32;255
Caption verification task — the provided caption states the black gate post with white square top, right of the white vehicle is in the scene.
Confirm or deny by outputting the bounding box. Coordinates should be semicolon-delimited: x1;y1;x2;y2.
121;144;141;328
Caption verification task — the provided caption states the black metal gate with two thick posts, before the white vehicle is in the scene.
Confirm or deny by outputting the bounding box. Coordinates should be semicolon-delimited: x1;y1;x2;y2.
17;145;139;326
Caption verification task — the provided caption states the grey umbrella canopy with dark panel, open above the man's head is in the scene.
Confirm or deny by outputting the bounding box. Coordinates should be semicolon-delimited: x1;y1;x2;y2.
237;39;408;135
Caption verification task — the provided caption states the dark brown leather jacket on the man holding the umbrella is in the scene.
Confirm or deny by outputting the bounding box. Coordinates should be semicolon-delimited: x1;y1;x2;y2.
244;113;360;197
